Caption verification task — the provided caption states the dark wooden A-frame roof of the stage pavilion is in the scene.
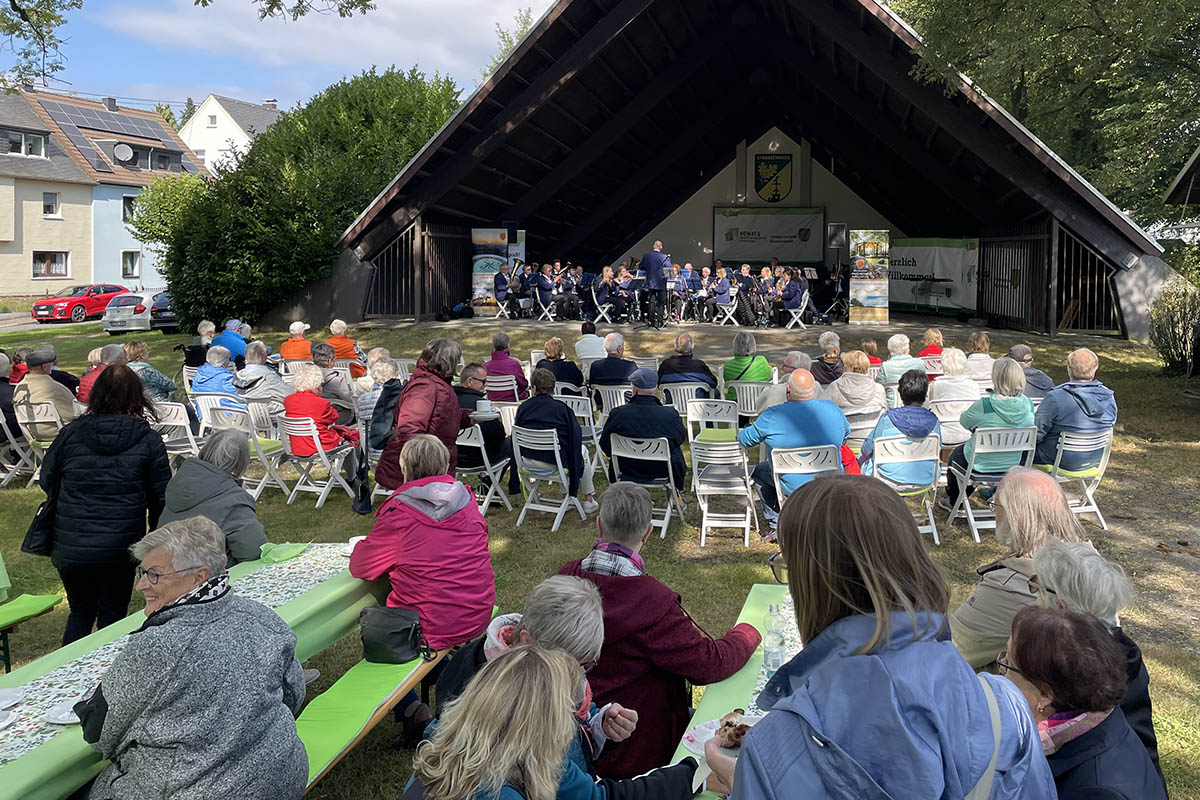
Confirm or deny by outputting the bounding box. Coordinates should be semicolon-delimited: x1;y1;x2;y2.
341;0;1160;267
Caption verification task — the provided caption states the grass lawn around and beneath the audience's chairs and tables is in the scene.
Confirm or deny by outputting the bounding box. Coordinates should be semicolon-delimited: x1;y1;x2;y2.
0;318;1200;800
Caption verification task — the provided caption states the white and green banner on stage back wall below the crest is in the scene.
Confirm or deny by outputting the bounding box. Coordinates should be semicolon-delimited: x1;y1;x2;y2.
713;205;824;266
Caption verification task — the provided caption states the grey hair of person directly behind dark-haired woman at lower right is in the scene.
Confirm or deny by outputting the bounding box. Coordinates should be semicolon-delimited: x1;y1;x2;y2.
1033;540;1134;627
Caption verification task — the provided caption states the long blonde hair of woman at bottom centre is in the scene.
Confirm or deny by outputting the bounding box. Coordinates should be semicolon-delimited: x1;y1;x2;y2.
413;644;582;800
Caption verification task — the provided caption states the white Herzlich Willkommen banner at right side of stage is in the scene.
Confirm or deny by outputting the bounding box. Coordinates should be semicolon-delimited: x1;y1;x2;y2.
888;239;979;311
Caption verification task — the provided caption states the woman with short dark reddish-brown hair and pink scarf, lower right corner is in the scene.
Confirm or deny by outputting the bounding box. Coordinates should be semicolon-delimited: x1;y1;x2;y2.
996;606;1166;800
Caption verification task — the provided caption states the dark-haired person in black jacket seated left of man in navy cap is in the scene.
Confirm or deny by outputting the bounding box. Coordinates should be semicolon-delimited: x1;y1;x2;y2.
509;369;597;513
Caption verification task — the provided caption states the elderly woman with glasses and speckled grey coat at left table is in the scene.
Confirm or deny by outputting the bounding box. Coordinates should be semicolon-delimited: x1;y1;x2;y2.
76;517;308;800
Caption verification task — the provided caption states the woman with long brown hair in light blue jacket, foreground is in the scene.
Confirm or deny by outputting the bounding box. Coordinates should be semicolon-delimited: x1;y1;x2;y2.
706;475;1055;800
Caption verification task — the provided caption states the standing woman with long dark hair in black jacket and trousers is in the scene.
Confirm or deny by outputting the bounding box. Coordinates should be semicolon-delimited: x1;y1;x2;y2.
41;366;170;645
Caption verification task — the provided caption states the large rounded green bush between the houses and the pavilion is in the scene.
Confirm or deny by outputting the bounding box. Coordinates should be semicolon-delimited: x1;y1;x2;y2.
159;67;458;325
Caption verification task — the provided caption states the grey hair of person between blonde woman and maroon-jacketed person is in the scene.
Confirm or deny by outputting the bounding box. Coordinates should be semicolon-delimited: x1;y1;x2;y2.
514;575;604;663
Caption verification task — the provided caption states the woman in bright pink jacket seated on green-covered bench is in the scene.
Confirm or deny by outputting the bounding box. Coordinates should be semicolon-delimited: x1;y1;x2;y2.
350;433;496;740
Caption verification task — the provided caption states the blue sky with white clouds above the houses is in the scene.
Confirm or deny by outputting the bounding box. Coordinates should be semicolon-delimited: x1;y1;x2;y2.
32;0;550;110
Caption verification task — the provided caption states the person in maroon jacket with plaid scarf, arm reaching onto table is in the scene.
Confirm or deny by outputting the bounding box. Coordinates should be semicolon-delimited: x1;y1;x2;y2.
559;481;762;778
